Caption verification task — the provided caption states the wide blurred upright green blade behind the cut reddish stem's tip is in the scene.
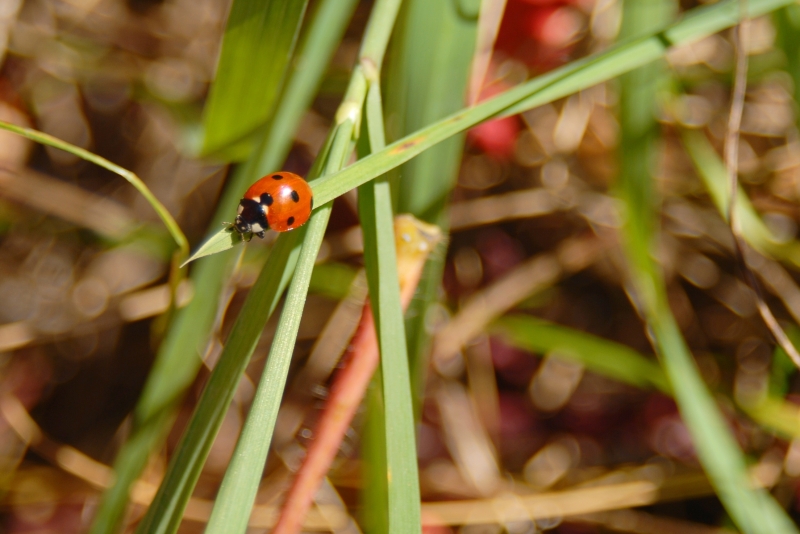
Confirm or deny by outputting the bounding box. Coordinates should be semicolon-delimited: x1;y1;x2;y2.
384;0;479;422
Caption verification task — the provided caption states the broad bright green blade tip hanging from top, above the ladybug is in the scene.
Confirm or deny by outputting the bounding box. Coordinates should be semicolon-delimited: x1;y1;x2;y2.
203;0;308;159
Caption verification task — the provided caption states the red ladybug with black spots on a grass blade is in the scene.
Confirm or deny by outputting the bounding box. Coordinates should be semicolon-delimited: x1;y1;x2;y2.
233;172;314;238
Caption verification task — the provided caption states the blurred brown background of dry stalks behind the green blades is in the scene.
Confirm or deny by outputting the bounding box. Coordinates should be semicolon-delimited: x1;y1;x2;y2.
0;0;800;534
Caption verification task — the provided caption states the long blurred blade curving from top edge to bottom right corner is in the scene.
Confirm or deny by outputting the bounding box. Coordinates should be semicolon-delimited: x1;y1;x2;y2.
619;0;797;534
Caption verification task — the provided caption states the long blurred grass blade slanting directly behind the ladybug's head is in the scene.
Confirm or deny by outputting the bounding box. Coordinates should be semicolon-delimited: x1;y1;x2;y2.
92;0;355;534
